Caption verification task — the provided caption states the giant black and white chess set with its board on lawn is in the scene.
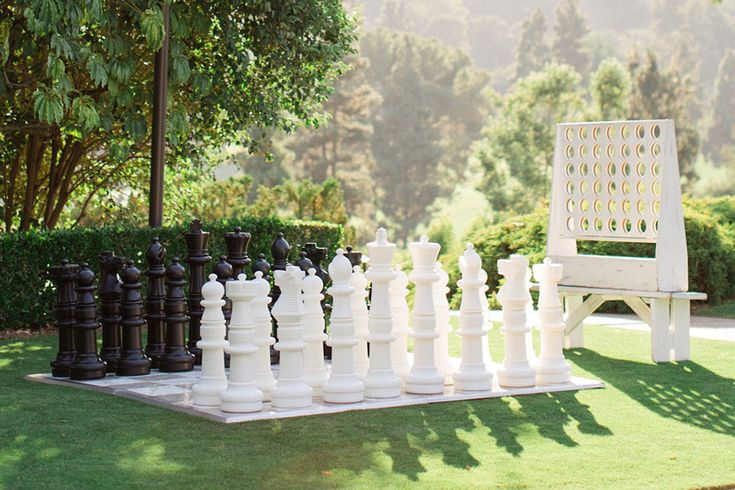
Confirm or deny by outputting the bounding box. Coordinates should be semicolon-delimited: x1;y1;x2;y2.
28;221;602;422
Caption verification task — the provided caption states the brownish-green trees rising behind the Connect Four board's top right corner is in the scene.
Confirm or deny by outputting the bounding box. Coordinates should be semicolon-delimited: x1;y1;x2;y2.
628;51;699;189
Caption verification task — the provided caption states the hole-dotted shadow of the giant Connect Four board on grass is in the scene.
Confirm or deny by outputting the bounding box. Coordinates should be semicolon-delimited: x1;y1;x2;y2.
572;349;735;436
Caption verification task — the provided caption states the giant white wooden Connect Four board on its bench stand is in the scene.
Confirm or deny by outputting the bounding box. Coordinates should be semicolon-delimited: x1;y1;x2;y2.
547;120;707;362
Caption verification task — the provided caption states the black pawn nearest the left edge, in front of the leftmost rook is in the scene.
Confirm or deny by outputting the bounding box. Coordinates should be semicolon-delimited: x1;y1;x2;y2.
69;263;107;380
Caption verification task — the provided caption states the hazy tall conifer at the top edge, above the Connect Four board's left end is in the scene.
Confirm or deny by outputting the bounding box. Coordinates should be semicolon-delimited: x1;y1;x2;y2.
551;0;589;74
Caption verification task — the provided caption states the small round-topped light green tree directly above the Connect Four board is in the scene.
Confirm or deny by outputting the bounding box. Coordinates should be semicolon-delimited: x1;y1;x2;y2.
590;58;631;121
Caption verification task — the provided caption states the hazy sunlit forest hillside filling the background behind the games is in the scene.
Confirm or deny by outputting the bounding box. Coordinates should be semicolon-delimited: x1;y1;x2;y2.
0;0;735;251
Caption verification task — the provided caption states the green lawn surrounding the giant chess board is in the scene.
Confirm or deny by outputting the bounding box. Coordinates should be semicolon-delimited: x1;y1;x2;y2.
0;327;735;489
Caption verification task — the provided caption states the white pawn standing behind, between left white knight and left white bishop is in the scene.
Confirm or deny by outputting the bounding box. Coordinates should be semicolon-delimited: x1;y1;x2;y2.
301;268;327;396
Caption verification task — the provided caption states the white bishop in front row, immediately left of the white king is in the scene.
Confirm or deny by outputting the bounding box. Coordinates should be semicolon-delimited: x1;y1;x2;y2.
322;249;365;403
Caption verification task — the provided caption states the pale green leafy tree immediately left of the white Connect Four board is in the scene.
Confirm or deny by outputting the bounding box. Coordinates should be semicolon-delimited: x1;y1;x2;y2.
472;64;583;213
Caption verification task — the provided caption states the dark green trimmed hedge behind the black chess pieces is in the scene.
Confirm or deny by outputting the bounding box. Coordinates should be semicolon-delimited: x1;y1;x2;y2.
0;217;343;328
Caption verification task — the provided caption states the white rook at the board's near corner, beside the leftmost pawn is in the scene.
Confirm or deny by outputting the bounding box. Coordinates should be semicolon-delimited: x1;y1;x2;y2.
220;274;263;413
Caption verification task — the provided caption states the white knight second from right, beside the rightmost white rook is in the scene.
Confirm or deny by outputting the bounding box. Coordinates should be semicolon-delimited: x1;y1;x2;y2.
498;255;536;388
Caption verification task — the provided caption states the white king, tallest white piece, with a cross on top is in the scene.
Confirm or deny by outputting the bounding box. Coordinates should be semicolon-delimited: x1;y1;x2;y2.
365;228;401;398
